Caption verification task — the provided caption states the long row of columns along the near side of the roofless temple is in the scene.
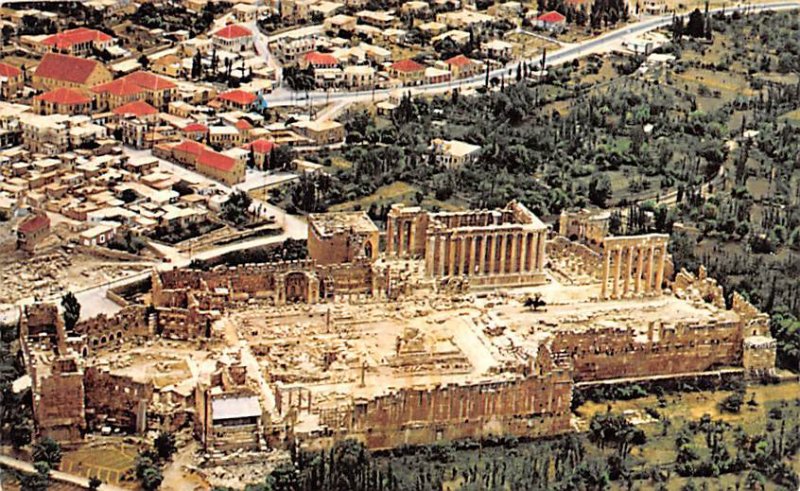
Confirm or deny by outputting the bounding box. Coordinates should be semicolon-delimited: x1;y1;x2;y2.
425;231;546;277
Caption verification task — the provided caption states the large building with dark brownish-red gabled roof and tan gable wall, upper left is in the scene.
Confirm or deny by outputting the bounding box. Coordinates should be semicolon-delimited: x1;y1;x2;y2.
33;53;112;90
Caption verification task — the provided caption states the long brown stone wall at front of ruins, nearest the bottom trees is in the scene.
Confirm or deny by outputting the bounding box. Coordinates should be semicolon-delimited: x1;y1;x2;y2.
340;370;573;449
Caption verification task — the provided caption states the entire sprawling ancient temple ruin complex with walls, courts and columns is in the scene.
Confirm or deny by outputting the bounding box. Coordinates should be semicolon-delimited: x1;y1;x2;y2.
20;202;776;456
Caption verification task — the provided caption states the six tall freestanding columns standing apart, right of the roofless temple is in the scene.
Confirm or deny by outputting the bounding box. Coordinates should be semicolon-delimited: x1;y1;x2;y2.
600;244;667;298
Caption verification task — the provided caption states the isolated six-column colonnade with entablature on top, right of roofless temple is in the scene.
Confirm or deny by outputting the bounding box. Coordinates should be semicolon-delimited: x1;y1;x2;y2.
600;234;669;299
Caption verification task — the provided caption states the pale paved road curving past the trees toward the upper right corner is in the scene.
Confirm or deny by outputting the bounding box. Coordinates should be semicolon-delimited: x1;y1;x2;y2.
266;2;800;106
